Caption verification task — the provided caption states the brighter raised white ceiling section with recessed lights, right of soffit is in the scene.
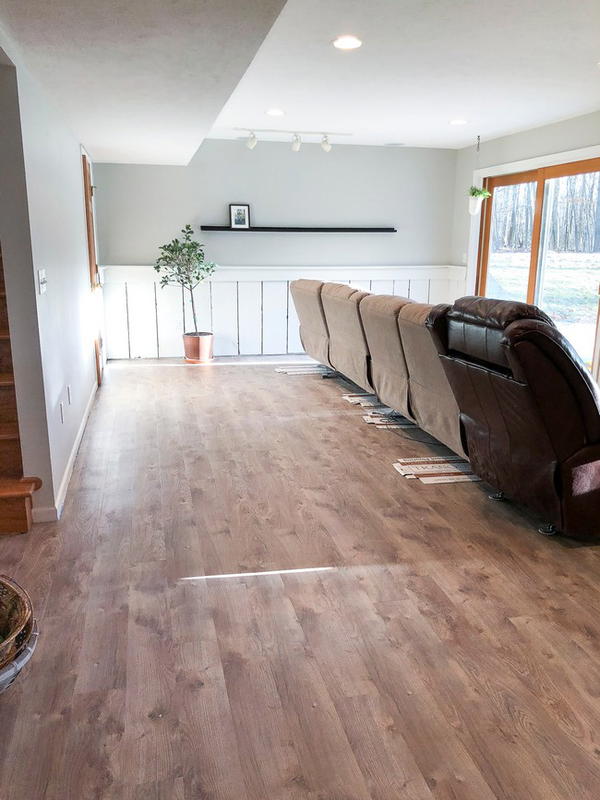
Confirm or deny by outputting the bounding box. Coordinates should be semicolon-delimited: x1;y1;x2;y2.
210;0;600;147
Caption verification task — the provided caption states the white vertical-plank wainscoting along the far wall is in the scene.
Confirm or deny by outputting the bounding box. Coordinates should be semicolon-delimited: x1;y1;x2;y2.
102;266;466;358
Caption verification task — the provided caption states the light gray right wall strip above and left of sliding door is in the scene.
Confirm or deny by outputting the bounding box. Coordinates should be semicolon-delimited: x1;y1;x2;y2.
451;111;600;272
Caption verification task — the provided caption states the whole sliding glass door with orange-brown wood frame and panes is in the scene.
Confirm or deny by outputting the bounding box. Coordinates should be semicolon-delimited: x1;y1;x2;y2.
478;159;600;369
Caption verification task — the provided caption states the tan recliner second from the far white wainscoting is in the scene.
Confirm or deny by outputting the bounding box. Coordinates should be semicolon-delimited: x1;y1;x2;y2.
321;283;373;392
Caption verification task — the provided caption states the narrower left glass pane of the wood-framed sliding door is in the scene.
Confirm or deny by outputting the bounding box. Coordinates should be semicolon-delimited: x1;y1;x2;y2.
485;182;537;302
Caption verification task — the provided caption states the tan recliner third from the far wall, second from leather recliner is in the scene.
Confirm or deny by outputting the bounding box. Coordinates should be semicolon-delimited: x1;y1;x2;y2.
360;294;413;419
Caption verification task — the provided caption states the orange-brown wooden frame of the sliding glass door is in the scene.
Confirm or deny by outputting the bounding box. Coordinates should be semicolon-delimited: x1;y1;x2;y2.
475;157;600;303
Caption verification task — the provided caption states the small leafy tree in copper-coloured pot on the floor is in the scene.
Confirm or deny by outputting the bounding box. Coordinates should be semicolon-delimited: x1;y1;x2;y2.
154;225;217;362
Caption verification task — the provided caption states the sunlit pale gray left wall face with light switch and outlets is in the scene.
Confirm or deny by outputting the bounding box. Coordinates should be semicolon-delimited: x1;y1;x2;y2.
17;65;98;510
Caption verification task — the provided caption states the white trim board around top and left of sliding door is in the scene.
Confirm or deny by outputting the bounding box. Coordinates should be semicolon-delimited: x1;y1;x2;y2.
465;144;600;294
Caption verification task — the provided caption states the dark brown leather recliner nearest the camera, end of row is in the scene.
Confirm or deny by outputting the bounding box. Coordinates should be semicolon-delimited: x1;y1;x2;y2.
427;297;600;539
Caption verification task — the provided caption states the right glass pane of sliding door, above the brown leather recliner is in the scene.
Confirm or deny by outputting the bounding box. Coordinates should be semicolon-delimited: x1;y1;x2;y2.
536;172;600;368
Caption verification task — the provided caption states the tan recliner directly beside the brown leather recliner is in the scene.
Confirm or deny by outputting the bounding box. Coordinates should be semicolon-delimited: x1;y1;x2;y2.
398;303;467;458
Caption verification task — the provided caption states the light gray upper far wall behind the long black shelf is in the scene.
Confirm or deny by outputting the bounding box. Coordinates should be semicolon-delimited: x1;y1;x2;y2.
94;139;456;266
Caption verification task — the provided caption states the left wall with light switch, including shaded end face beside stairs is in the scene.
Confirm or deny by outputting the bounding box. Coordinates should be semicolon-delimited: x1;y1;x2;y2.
0;37;99;512
